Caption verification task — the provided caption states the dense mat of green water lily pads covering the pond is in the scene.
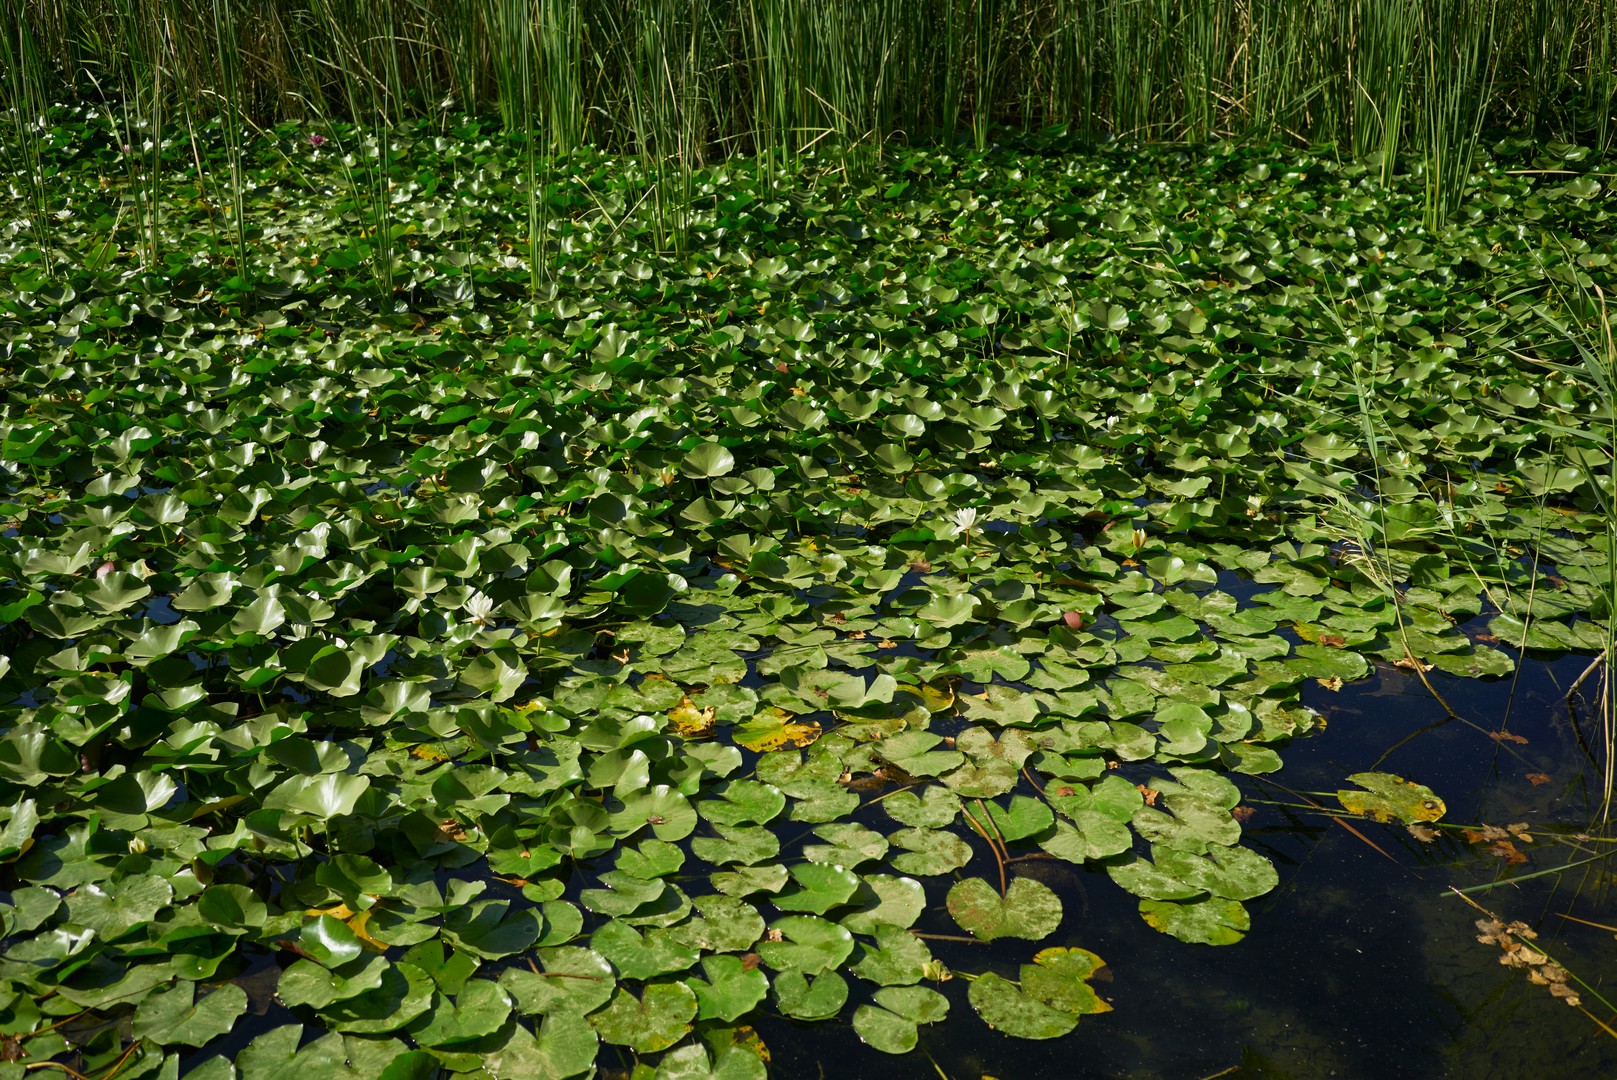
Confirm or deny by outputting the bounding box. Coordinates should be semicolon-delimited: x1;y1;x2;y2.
0;99;1611;1077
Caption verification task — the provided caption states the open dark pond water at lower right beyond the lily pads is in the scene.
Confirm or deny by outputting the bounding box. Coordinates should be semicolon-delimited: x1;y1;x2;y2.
753;656;1617;1080
